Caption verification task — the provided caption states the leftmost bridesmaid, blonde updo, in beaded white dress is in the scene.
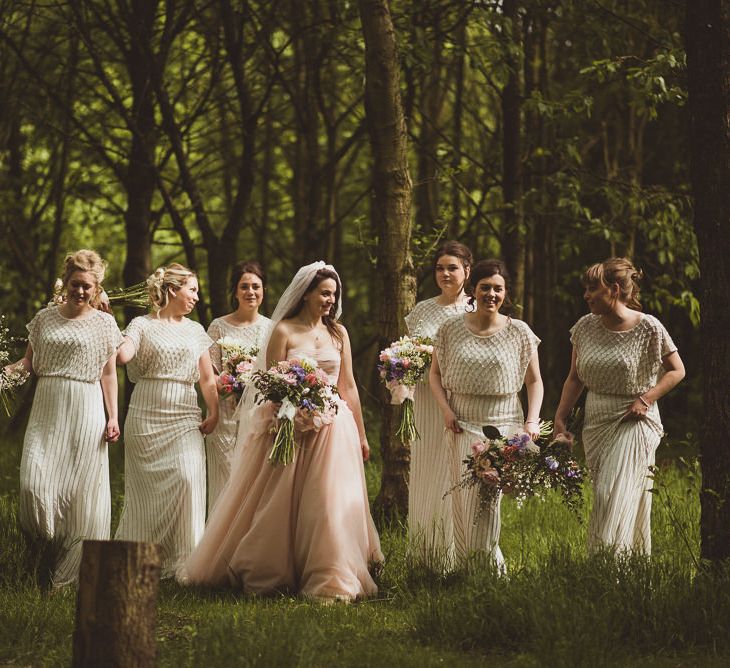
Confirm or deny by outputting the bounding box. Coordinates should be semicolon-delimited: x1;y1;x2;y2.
7;250;122;587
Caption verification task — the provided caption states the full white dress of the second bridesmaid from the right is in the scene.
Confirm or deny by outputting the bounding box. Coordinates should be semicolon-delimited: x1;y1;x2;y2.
435;316;540;570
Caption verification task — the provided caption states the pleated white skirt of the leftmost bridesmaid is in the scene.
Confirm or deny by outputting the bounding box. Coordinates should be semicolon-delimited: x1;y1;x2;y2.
20;376;111;586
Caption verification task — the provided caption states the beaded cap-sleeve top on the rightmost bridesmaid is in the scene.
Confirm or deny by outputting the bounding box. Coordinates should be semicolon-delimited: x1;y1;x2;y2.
570;313;677;395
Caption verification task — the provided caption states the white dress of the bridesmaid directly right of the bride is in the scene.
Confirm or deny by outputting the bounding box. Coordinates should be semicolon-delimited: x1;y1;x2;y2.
405;297;466;564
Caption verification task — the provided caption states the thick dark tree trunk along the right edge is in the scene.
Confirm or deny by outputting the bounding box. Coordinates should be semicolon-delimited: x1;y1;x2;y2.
686;0;730;561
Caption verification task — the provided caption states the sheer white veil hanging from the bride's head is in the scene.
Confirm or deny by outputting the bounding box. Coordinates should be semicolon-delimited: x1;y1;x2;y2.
234;260;342;448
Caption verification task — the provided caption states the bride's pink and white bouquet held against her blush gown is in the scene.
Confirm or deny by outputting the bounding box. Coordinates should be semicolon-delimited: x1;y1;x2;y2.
251;357;337;466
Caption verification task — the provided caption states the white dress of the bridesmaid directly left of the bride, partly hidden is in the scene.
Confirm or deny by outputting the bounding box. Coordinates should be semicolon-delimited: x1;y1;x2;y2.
205;315;271;513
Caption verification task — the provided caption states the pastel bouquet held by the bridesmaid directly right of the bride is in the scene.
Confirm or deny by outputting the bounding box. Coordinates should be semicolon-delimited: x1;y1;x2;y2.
378;336;433;443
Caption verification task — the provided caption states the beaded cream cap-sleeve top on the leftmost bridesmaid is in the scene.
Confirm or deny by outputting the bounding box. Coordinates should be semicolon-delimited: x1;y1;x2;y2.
28;306;122;383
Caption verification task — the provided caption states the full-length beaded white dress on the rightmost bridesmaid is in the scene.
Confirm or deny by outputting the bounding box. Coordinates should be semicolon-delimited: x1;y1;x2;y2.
570;314;677;554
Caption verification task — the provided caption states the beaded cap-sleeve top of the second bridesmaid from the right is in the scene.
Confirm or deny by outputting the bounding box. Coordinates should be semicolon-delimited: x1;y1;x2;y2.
434;315;540;395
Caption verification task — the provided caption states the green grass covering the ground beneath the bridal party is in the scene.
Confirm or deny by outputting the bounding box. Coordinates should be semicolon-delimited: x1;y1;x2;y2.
0;420;730;668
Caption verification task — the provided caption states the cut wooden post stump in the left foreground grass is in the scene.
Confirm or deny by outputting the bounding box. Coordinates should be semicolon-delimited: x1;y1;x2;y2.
72;540;160;668
